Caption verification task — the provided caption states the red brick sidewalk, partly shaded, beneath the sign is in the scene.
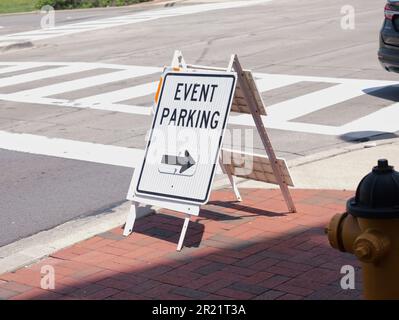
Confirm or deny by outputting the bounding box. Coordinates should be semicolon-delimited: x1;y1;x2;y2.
0;189;361;300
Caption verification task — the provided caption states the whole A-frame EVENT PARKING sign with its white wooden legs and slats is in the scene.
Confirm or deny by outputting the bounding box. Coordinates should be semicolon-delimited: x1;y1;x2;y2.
123;51;296;251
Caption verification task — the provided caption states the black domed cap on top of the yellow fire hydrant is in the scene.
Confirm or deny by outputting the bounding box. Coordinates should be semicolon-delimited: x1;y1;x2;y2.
346;159;399;219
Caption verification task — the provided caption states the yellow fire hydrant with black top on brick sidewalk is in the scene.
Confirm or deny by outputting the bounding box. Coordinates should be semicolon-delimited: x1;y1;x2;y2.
326;159;399;299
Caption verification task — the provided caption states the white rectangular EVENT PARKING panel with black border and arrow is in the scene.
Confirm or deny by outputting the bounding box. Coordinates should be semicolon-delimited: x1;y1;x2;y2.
134;72;236;204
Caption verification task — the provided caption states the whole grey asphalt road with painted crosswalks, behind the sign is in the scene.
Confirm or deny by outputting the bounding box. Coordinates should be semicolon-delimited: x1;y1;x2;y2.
0;0;399;246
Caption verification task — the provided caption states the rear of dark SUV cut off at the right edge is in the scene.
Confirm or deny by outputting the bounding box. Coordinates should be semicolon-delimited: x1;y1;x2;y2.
378;0;399;72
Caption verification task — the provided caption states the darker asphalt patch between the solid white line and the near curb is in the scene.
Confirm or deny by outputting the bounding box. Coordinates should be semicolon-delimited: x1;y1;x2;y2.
0;150;132;246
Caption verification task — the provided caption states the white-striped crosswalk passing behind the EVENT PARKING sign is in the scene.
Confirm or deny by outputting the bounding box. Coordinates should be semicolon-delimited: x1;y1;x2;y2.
0;62;399;138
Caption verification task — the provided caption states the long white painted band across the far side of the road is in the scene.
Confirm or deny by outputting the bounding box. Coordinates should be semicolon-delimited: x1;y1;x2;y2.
0;0;272;49
